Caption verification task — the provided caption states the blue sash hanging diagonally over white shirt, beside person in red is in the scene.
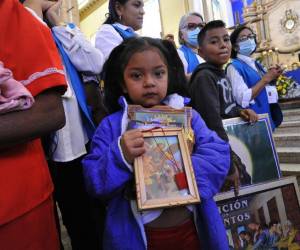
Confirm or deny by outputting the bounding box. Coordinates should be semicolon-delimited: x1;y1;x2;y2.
52;32;96;139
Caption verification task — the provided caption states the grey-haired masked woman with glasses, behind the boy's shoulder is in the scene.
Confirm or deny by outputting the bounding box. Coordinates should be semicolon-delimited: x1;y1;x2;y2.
177;12;204;75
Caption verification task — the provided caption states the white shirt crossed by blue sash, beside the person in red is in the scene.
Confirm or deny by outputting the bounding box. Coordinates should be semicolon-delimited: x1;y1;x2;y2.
53;26;104;162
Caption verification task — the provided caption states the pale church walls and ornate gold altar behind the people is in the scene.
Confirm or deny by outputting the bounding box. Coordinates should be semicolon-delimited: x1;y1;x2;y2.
59;0;300;99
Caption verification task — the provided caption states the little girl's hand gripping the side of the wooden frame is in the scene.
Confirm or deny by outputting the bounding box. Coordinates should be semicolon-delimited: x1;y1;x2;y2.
121;129;146;164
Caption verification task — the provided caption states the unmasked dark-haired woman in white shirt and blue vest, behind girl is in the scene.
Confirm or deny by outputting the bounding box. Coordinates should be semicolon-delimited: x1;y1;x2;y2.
96;0;145;67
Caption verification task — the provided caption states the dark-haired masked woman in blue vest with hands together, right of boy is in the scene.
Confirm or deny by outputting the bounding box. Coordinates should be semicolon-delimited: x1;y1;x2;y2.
226;26;283;130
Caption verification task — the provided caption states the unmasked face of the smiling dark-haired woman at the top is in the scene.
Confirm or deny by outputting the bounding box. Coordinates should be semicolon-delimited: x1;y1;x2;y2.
116;0;145;30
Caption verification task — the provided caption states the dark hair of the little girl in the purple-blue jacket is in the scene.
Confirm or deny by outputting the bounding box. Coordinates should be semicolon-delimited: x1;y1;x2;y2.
104;37;188;113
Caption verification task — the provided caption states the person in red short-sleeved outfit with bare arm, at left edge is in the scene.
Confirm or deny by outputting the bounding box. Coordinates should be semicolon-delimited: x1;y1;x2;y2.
0;0;66;250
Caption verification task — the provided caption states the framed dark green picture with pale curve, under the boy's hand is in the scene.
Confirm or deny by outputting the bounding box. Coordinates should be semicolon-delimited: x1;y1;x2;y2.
223;114;281;189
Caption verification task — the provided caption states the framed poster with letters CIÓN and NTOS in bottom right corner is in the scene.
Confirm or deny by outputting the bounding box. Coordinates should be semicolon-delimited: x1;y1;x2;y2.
215;177;300;249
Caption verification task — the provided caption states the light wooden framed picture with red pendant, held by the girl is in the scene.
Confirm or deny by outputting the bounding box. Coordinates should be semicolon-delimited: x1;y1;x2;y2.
134;128;200;210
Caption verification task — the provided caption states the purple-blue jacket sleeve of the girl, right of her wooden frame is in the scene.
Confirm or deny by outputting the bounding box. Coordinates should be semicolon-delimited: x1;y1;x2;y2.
191;111;230;199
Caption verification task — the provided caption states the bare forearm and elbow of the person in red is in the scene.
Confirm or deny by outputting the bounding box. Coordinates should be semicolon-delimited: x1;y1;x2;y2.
0;89;65;149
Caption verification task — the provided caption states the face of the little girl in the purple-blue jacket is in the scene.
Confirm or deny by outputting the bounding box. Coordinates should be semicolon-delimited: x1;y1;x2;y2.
123;48;168;108
